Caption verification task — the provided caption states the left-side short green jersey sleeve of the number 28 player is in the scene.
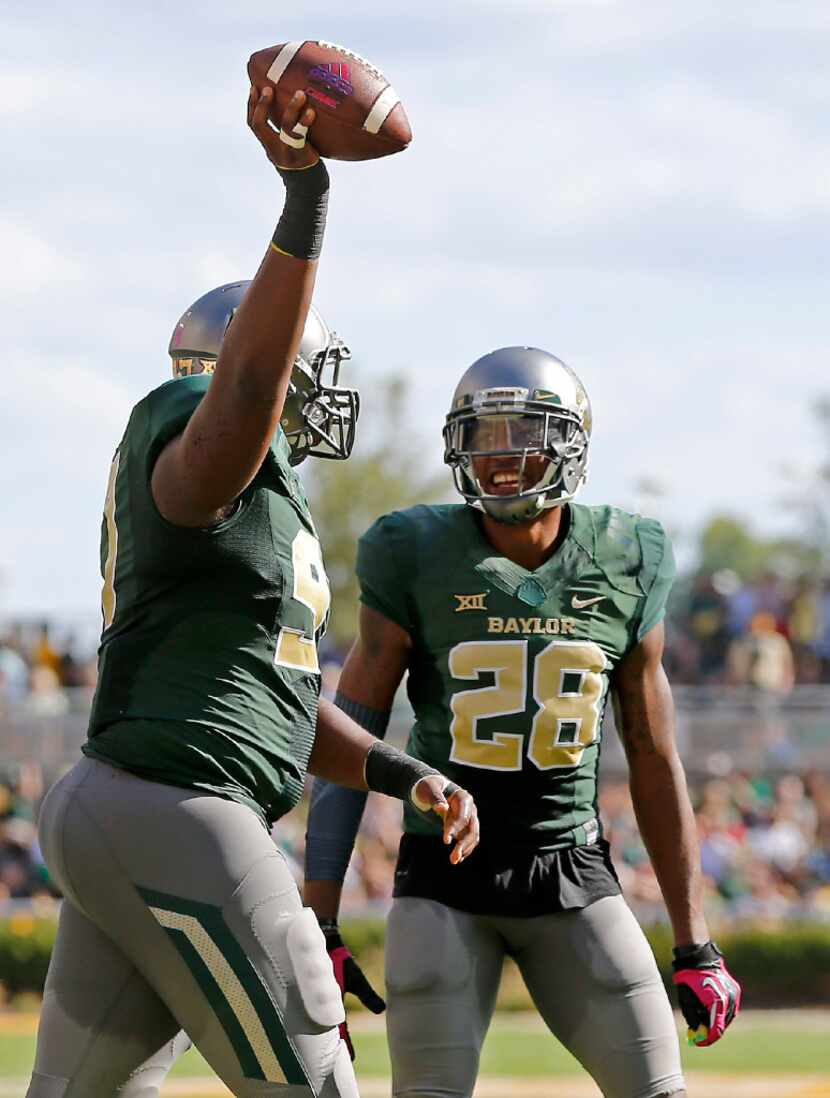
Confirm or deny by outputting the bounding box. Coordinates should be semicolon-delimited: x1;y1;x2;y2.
357;513;415;632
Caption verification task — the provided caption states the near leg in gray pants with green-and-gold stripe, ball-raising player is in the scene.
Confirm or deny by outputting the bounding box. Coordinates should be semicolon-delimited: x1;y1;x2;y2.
45;761;357;1098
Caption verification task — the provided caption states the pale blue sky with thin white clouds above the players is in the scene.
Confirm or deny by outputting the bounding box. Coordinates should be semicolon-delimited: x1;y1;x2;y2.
0;0;830;618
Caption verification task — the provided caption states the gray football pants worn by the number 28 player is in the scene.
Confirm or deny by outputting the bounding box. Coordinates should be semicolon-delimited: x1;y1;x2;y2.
386;896;685;1098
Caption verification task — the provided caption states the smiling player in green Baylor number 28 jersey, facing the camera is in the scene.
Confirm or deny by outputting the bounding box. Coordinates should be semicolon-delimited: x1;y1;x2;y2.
305;347;740;1098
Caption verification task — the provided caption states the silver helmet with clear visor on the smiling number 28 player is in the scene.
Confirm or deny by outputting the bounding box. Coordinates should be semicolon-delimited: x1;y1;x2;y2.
444;347;592;523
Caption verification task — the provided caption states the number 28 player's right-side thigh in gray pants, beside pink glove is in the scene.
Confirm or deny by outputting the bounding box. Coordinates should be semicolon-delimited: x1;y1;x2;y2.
515;896;684;1098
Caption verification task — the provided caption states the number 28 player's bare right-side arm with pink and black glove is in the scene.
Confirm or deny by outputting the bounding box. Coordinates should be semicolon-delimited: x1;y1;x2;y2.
614;623;741;1045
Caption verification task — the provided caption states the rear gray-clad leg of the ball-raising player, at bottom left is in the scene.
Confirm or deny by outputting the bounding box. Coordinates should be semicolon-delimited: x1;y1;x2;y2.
29;901;179;1098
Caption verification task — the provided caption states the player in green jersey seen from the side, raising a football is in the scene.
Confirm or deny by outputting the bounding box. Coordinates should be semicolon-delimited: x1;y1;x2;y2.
29;88;476;1098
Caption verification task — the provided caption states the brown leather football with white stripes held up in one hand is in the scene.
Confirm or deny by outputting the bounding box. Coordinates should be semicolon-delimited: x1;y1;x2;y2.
248;42;412;160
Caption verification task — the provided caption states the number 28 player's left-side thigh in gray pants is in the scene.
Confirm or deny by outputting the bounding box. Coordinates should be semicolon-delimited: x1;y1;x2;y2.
385;898;504;1098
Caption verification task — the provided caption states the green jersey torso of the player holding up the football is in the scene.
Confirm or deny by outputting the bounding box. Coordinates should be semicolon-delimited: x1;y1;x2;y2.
85;374;329;822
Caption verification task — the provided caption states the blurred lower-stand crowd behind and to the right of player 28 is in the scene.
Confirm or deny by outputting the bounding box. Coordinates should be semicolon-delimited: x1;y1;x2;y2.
265;773;830;925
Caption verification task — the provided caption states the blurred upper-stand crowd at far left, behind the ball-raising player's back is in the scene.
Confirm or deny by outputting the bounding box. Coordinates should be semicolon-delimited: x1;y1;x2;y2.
0;623;97;717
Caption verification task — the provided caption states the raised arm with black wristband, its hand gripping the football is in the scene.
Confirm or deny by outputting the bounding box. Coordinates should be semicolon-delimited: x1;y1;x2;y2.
152;88;328;526
